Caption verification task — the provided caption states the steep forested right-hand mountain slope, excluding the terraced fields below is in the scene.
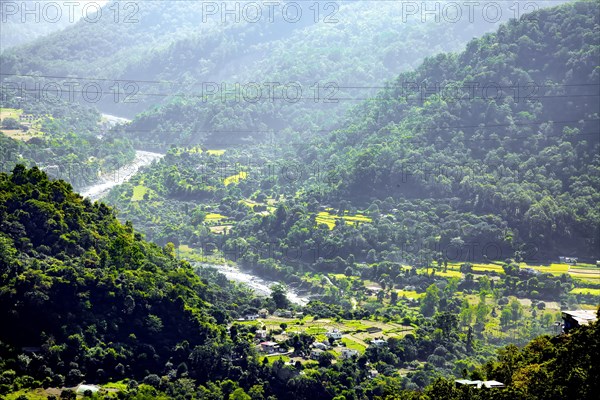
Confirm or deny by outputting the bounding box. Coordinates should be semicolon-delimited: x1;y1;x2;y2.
308;2;600;257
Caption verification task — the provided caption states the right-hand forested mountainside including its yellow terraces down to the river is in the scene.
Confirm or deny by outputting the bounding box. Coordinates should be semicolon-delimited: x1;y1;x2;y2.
109;2;600;276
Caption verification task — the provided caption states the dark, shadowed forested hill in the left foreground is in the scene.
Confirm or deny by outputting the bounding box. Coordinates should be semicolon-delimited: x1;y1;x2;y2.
0;165;258;392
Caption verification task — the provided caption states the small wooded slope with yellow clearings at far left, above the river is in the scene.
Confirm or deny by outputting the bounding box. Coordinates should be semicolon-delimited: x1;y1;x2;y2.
0;89;134;189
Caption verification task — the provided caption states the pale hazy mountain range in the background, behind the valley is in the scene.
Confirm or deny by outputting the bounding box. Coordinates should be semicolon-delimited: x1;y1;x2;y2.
0;1;555;140
